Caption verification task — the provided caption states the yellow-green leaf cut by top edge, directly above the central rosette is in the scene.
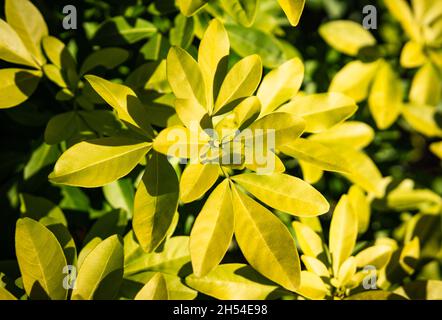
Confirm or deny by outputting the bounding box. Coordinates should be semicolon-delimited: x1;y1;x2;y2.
220;0;258;27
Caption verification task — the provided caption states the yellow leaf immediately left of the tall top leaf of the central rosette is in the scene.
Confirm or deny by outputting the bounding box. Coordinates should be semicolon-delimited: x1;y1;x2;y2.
167;47;207;106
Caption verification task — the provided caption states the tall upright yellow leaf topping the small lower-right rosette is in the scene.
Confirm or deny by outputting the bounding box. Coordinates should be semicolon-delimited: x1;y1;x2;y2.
329;195;358;275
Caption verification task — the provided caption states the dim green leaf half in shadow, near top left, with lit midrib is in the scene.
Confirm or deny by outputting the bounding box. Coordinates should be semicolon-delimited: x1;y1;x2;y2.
92;16;157;46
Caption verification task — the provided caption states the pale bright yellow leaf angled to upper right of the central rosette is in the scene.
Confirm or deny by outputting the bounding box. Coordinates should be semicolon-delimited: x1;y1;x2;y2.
257;58;304;115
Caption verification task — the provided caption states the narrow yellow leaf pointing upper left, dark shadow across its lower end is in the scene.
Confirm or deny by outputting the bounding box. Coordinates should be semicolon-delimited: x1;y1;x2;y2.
85;75;153;138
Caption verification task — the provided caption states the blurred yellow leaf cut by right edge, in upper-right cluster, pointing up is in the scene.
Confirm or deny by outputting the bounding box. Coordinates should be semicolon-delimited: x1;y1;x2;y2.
409;63;442;106
